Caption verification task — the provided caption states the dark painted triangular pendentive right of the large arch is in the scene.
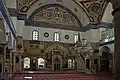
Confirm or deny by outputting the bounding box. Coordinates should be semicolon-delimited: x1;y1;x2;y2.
73;0;108;24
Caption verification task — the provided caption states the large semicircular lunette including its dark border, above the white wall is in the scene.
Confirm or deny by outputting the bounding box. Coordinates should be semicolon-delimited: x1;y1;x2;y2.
26;4;83;31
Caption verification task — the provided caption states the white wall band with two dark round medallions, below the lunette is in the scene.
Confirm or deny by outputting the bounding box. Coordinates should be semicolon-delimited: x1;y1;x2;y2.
23;26;78;43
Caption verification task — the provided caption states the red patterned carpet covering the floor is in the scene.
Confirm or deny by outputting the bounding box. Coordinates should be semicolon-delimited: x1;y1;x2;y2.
12;71;114;80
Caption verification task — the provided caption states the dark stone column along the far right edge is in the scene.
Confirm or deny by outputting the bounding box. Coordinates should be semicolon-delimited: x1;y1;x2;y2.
113;10;120;80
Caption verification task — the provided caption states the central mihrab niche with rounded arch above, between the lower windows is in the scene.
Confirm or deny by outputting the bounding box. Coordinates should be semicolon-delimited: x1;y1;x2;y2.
45;44;69;71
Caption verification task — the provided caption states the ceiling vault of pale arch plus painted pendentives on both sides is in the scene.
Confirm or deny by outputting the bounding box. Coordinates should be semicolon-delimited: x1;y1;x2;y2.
17;0;108;31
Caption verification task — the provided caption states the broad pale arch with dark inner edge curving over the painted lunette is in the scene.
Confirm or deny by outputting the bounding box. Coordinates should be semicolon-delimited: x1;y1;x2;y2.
27;0;89;27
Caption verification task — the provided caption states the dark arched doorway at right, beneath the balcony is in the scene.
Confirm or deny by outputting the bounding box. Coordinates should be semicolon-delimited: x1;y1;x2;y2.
100;46;112;71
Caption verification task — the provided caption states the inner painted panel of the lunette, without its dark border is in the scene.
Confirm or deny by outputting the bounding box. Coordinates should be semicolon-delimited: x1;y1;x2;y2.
33;7;79;26
